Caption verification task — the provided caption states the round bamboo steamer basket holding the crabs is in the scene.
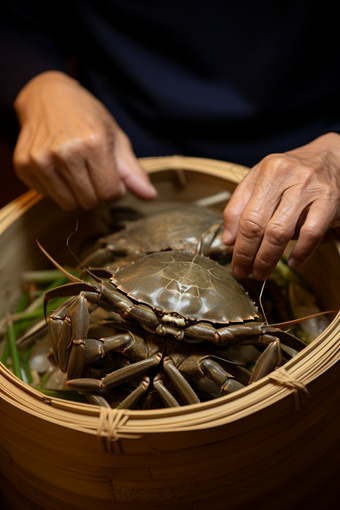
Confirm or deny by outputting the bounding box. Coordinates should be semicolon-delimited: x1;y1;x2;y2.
0;156;340;510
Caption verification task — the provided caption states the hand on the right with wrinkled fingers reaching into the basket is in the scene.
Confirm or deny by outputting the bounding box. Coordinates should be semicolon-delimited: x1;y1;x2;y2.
223;132;340;280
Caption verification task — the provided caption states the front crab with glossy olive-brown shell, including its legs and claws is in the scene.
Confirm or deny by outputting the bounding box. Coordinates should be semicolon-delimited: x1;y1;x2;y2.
39;244;305;410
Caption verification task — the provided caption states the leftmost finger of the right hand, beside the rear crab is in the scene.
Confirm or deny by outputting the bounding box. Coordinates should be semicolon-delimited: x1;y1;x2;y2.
222;166;259;246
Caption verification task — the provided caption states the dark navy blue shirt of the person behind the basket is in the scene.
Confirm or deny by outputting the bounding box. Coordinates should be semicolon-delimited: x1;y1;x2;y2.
0;0;340;166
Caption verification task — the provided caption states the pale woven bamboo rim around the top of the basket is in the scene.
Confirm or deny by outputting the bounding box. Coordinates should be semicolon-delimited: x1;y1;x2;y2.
0;152;340;438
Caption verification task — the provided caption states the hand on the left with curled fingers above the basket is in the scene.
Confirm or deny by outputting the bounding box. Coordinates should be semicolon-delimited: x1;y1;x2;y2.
13;71;156;210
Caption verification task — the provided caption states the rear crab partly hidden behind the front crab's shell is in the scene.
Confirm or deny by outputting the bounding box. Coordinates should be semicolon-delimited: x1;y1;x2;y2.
82;205;231;271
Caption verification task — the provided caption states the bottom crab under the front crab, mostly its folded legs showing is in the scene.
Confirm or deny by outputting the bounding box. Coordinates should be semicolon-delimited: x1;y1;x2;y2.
62;325;251;408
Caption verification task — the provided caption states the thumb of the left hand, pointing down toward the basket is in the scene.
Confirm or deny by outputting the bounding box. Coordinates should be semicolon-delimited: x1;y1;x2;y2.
115;130;157;200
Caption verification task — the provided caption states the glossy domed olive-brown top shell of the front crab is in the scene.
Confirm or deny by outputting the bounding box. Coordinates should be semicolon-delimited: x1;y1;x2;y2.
111;251;257;326
